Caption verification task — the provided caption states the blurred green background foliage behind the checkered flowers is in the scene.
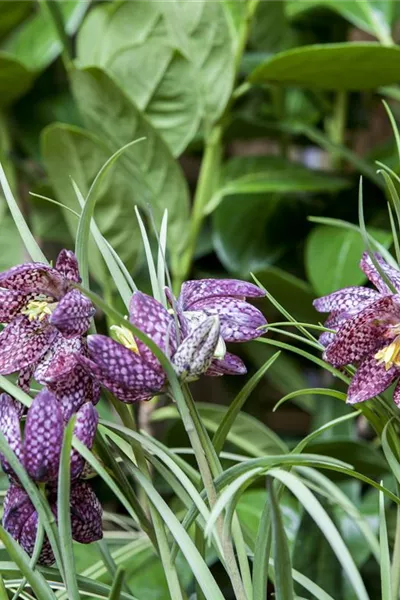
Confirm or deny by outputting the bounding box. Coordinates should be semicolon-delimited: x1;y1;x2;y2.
0;0;400;600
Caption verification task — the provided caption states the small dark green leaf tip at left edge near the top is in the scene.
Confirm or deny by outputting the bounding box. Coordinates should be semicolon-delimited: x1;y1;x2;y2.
0;51;33;106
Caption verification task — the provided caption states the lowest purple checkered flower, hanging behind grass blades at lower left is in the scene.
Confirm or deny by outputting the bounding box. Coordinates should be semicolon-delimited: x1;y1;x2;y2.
0;389;102;564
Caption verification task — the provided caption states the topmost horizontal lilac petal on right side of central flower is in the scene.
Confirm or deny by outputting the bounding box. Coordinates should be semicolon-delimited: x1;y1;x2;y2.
178;279;265;310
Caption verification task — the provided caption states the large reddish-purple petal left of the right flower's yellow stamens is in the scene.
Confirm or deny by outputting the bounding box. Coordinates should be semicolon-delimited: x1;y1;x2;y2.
324;296;400;367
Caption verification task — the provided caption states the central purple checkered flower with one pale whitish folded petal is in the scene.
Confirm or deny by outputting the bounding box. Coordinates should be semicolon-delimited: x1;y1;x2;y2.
79;280;266;402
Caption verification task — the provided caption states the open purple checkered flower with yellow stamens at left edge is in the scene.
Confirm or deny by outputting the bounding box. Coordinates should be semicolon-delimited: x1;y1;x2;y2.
0;250;99;420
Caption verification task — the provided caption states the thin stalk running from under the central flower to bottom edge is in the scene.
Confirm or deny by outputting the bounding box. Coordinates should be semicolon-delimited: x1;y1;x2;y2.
178;385;248;600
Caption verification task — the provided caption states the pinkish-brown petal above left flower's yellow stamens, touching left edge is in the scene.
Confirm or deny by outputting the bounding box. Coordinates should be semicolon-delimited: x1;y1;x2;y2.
0;263;65;298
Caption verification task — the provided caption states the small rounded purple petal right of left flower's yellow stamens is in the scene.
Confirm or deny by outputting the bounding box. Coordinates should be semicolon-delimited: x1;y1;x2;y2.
50;290;96;337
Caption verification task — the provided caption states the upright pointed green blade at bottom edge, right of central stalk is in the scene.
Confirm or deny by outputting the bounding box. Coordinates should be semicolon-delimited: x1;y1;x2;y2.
267;477;294;600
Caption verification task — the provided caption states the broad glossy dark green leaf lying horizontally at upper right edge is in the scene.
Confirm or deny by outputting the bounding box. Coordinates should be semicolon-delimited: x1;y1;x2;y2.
250;42;400;90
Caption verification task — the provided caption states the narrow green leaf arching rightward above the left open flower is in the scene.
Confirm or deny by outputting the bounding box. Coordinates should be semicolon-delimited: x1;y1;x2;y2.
75;138;144;287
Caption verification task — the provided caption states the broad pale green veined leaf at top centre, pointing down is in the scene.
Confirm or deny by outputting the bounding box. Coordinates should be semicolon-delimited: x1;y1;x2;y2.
78;0;234;155
